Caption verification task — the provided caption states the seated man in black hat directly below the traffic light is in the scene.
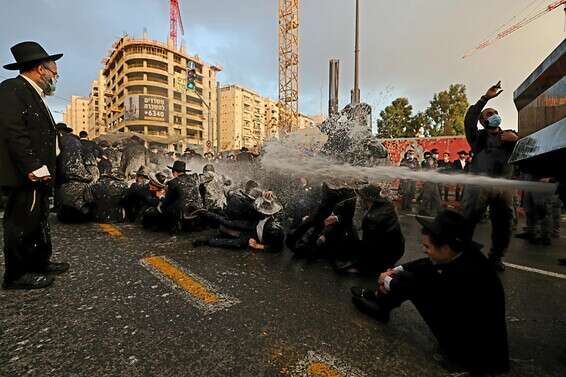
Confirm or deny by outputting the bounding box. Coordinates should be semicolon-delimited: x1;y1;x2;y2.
161;161;204;231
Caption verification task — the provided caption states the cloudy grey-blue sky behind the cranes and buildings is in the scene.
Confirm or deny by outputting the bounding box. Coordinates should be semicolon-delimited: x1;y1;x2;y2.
0;0;566;128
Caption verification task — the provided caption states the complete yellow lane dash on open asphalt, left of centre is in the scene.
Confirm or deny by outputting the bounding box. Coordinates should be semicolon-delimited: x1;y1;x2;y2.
140;256;240;314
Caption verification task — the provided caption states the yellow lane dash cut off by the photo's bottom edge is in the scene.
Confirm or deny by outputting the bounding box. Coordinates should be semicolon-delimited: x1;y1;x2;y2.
291;351;366;377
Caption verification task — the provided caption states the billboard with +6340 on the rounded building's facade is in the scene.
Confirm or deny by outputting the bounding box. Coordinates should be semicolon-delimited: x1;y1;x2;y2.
124;95;169;122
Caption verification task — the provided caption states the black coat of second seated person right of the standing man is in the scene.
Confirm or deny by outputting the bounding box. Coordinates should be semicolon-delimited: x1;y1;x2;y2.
91;175;128;223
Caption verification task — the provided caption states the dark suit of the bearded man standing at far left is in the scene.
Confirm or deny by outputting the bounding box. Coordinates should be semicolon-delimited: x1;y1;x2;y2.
0;77;56;282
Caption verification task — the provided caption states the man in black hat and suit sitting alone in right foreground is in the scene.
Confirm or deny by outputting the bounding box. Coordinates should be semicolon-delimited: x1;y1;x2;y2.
351;210;509;374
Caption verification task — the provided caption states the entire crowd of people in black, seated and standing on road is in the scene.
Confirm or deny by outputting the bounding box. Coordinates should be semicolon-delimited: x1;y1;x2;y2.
0;42;555;374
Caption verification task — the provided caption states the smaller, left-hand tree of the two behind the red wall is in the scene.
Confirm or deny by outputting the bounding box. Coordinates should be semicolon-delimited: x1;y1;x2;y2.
377;97;416;138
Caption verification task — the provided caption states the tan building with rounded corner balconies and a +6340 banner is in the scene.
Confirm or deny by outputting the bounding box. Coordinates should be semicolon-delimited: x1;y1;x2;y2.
99;34;221;152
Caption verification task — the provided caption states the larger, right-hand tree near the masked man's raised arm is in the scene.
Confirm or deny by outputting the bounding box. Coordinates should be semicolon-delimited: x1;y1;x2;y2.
425;84;469;136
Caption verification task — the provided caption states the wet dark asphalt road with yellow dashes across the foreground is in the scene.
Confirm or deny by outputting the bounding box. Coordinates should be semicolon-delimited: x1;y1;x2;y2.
0;215;566;377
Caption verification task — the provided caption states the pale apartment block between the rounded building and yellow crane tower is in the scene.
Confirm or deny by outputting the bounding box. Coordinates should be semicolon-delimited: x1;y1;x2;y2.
220;85;279;151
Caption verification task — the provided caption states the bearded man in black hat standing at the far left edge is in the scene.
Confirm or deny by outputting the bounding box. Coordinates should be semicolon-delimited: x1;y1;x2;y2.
0;42;69;289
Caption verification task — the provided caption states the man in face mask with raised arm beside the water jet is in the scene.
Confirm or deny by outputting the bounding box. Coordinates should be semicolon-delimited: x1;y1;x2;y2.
463;82;518;271
